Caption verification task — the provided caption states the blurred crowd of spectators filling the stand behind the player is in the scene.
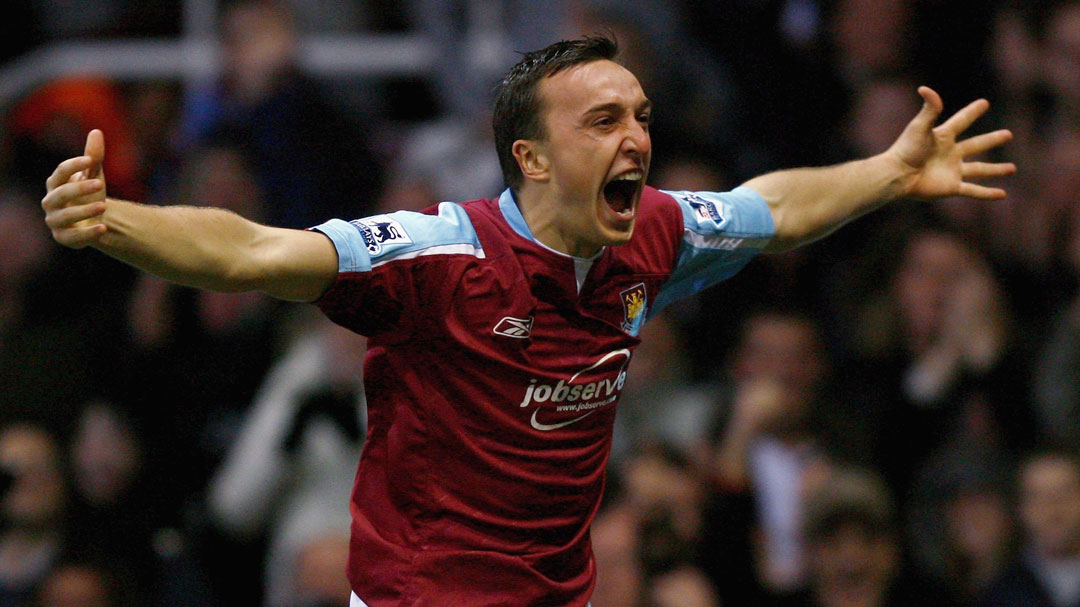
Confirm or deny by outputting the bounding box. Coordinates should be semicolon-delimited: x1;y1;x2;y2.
0;0;1080;607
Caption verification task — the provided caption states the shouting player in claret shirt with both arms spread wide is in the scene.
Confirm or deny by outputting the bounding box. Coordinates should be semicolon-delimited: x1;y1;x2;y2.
42;38;1015;607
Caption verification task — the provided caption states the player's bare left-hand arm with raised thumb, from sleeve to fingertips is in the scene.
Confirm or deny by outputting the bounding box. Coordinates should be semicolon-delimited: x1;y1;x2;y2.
41;130;337;301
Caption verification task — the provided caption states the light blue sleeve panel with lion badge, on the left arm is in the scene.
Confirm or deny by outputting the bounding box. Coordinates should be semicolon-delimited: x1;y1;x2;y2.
312;202;484;273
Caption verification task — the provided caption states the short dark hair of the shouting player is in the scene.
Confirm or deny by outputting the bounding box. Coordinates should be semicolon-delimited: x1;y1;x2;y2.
491;35;619;190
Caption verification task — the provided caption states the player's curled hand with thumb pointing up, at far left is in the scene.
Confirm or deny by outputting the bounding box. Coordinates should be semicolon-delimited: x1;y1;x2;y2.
41;129;107;248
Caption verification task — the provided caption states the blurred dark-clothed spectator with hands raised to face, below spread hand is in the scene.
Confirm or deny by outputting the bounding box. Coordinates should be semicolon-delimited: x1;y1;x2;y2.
856;226;1035;504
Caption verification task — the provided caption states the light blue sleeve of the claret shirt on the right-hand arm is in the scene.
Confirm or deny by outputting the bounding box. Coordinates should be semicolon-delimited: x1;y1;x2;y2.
651;187;775;314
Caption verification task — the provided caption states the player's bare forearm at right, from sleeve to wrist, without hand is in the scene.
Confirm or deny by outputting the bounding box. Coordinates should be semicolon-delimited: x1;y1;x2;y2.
744;152;910;252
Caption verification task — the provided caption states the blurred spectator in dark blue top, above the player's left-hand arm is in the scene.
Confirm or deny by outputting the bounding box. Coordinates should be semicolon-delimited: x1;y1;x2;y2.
181;0;382;228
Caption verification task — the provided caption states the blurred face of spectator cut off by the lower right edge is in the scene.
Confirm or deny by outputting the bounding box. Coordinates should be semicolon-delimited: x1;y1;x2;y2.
1020;458;1080;558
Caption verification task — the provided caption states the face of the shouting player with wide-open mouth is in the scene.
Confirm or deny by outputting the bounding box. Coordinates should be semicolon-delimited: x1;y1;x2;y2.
536;60;652;257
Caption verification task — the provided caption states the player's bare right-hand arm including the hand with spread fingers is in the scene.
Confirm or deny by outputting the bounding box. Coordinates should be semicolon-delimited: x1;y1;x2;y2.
744;86;1016;252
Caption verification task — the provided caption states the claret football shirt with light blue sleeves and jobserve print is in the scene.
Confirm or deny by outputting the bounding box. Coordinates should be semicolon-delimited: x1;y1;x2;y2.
314;188;773;607
